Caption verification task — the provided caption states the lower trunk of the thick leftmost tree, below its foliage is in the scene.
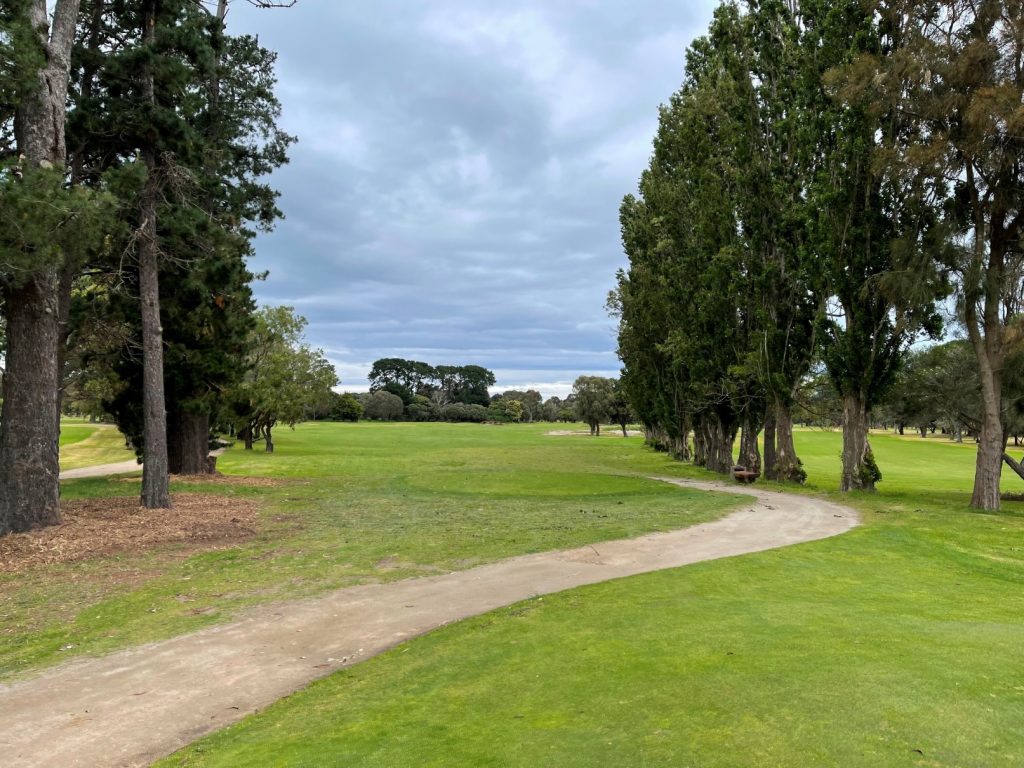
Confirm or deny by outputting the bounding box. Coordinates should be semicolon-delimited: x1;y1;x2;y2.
0;269;60;536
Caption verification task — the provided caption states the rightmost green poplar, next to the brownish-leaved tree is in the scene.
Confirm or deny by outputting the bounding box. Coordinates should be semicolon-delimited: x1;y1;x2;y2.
802;0;944;490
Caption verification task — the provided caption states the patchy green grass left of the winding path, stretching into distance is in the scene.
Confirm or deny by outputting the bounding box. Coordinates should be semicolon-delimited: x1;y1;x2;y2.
0;424;738;677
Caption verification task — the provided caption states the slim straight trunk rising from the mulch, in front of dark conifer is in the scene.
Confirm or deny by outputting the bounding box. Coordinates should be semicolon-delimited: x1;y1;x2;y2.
138;0;171;509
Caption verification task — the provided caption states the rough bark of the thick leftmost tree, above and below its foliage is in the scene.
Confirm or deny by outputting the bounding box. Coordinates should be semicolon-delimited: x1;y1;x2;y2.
0;0;80;536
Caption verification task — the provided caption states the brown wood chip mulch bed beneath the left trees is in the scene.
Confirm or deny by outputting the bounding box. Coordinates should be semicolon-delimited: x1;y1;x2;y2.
0;494;258;573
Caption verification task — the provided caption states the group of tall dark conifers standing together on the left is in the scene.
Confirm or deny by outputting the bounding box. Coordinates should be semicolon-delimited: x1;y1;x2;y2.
0;0;303;534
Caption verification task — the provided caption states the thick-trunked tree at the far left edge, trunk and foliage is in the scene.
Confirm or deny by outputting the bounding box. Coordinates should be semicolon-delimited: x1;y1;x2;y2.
0;0;83;535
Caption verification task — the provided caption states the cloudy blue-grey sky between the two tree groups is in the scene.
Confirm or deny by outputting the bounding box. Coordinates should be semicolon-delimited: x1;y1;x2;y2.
228;0;715;396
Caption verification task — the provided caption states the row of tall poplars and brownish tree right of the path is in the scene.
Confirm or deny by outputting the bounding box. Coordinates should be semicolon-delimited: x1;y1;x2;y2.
609;0;1024;509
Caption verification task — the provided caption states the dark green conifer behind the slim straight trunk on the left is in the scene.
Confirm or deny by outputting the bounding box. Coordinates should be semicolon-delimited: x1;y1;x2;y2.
69;0;293;474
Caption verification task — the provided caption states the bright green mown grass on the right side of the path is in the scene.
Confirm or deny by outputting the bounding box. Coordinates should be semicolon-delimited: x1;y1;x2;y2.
162;429;1024;767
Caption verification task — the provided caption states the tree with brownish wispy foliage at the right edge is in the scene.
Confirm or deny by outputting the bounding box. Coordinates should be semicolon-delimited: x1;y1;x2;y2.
861;0;1024;509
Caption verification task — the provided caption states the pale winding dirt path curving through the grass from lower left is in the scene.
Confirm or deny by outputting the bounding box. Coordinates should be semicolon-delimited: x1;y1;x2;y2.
0;478;858;768
